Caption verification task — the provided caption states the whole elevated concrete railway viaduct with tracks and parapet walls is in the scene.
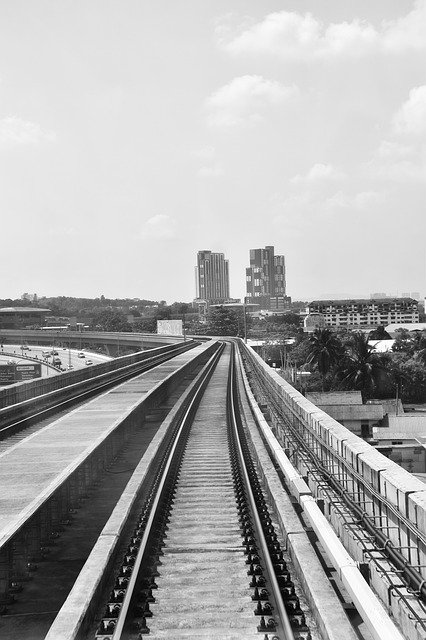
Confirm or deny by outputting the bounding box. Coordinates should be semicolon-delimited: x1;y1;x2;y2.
0;340;426;640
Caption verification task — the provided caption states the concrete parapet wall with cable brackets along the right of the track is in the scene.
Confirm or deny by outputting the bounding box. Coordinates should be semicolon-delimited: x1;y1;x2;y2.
240;341;426;638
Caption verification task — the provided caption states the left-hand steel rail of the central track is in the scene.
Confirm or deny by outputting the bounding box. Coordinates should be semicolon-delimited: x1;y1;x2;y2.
112;344;225;640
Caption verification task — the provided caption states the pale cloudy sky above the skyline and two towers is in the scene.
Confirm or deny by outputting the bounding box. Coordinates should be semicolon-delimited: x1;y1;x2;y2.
0;0;426;302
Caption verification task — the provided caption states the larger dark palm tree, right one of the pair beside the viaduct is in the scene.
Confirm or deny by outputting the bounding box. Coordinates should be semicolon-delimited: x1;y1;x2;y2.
339;332;387;395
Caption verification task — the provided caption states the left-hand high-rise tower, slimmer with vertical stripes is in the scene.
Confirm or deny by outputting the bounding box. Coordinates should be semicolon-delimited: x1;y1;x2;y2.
195;250;229;304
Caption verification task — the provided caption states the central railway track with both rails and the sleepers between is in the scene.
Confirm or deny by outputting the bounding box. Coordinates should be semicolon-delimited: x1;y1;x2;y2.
90;344;310;640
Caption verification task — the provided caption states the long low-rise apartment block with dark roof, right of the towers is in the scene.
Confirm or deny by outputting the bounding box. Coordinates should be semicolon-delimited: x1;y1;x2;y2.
306;298;419;329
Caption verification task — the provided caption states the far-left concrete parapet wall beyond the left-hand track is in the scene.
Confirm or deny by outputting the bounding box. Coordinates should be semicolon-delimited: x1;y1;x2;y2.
0;341;196;409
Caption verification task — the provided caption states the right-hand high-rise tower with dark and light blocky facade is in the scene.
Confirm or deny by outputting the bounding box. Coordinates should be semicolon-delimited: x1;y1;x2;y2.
246;246;286;310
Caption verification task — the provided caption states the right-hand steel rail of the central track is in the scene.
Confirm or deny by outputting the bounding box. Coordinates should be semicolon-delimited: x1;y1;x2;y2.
228;343;294;640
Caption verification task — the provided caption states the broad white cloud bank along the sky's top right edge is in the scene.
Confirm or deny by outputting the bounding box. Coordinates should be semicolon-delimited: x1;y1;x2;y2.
216;0;426;60
